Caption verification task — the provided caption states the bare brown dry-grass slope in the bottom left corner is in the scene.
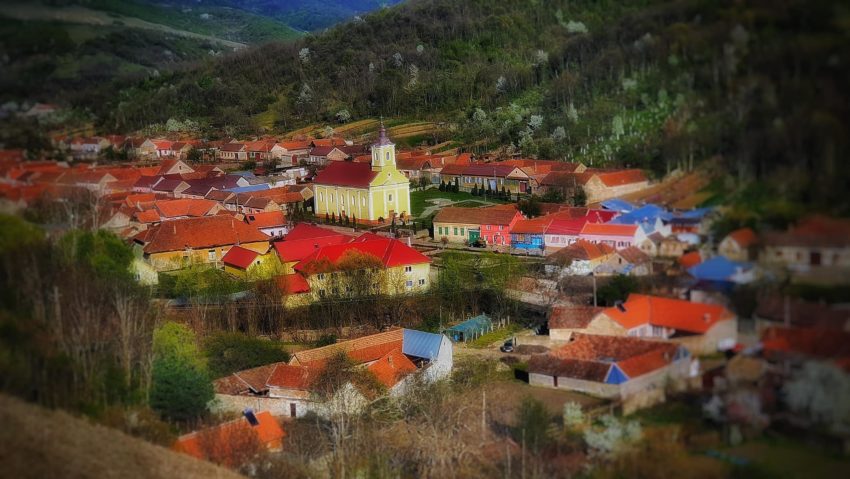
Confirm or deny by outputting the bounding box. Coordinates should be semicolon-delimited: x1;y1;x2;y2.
0;395;242;479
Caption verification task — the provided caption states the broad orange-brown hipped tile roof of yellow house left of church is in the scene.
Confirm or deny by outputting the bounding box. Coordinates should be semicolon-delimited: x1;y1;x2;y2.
140;215;269;254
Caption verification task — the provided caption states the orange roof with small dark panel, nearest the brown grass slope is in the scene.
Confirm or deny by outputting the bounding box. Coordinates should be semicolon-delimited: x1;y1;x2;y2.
171;411;286;466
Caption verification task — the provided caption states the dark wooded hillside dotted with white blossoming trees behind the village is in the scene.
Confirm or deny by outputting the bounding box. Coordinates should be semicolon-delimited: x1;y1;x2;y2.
99;0;850;215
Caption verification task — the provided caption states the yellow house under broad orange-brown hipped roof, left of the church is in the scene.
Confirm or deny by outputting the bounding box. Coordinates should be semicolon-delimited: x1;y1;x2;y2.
133;215;269;280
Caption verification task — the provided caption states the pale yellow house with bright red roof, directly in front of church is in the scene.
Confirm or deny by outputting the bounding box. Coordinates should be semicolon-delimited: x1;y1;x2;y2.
294;233;431;300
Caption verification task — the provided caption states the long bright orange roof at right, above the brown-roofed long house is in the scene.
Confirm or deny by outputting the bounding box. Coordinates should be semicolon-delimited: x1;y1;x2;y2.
604;294;734;334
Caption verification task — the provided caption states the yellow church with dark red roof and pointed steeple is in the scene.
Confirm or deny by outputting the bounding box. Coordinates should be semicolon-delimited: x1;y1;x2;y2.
313;123;410;221
